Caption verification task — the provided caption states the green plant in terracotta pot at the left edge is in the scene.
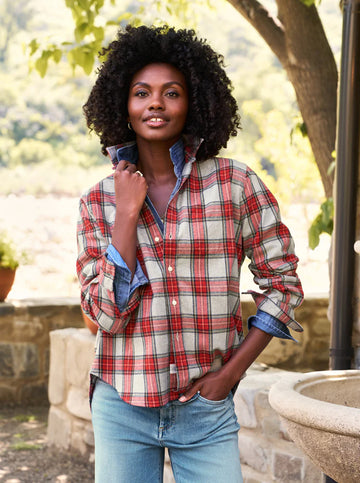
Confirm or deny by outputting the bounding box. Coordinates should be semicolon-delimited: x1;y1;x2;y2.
0;232;23;302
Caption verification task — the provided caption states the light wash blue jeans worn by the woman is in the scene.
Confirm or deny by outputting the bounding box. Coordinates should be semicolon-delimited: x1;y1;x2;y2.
92;379;243;483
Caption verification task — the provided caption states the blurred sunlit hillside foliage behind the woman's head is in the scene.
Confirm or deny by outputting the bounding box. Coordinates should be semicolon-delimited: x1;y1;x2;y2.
0;0;340;250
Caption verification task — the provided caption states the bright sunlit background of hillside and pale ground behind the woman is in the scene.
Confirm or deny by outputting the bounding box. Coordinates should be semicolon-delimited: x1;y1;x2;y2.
0;0;341;299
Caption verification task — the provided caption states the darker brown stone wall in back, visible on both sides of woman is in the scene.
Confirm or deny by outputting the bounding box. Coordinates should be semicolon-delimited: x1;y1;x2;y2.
0;296;330;404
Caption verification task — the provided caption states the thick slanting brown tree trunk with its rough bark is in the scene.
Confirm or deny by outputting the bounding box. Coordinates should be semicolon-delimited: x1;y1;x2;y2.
228;0;338;197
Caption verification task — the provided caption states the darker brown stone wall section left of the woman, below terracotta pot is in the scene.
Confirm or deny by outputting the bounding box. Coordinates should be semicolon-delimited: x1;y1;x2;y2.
0;298;83;404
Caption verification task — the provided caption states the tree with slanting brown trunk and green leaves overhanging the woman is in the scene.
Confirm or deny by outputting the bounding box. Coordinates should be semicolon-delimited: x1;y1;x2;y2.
30;0;338;198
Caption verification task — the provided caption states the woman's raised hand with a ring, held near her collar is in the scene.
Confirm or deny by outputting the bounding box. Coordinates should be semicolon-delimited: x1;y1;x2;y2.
114;160;148;217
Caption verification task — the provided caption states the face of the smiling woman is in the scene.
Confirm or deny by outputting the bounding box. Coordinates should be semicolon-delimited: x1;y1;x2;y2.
128;63;189;147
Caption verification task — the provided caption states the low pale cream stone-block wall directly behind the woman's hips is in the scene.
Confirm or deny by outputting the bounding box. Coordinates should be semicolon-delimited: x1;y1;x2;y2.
48;329;323;483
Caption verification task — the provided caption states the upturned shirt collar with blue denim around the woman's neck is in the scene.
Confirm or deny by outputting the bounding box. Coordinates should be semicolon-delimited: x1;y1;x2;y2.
106;136;203;178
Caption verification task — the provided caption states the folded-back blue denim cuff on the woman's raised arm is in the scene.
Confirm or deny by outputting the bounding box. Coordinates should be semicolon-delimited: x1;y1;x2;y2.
106;244;149;311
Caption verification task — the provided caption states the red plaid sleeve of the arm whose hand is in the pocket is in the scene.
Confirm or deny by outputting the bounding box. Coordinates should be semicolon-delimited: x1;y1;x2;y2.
242;170;304;332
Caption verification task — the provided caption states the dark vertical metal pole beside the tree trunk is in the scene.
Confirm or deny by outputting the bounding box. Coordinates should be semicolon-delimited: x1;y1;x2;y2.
330;0;360;370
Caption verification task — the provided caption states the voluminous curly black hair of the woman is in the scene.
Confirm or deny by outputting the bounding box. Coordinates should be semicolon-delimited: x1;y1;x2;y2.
83;25;240;161
